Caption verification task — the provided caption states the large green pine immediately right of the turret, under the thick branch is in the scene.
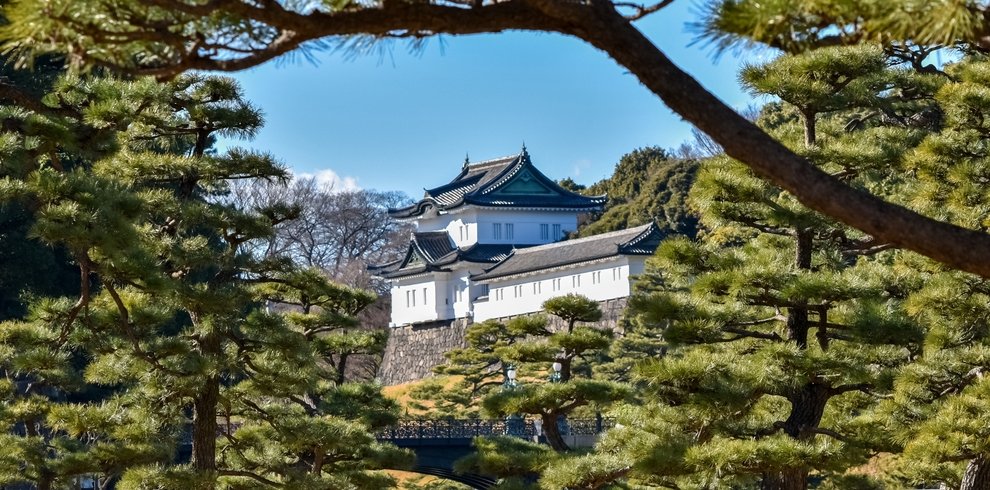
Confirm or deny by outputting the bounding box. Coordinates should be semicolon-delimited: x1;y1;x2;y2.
551;47;940;489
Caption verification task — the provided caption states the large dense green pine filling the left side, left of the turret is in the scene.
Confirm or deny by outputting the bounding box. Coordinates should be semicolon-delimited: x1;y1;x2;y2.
0;71;404;488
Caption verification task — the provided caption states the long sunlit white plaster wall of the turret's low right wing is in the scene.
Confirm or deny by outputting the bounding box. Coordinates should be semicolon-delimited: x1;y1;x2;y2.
474;256;645;322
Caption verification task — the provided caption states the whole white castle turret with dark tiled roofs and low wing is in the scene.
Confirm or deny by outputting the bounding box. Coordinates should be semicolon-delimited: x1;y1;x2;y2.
372;147;663;326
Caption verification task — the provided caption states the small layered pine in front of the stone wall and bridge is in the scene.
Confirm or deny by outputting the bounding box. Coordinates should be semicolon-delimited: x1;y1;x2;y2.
418;294;631;488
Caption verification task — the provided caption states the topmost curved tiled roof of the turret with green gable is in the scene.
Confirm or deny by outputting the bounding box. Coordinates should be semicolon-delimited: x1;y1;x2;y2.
389;147;605;219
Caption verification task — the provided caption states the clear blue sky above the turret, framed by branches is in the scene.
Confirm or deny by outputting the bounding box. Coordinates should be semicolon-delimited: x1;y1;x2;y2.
221;0;769;197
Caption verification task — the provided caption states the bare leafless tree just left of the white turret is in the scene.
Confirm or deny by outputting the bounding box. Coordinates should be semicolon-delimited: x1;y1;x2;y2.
225;178;410;382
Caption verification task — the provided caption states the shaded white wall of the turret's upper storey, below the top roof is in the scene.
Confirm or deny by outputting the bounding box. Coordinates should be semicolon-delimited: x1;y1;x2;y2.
476;209;579;245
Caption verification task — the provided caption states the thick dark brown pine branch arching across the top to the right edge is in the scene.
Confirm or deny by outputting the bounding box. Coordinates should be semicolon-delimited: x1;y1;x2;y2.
15;0;990;277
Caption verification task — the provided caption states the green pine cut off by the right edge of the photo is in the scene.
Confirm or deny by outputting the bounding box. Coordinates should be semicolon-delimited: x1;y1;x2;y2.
879;57;990;490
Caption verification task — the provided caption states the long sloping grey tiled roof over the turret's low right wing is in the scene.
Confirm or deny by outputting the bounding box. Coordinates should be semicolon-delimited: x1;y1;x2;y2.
471;223;664;280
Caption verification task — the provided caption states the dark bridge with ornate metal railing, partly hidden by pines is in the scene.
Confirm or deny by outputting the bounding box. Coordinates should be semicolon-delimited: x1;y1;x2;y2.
378;418;614;490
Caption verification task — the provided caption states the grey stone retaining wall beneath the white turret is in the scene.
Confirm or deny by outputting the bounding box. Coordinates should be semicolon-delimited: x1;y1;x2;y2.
378;298;627;386
